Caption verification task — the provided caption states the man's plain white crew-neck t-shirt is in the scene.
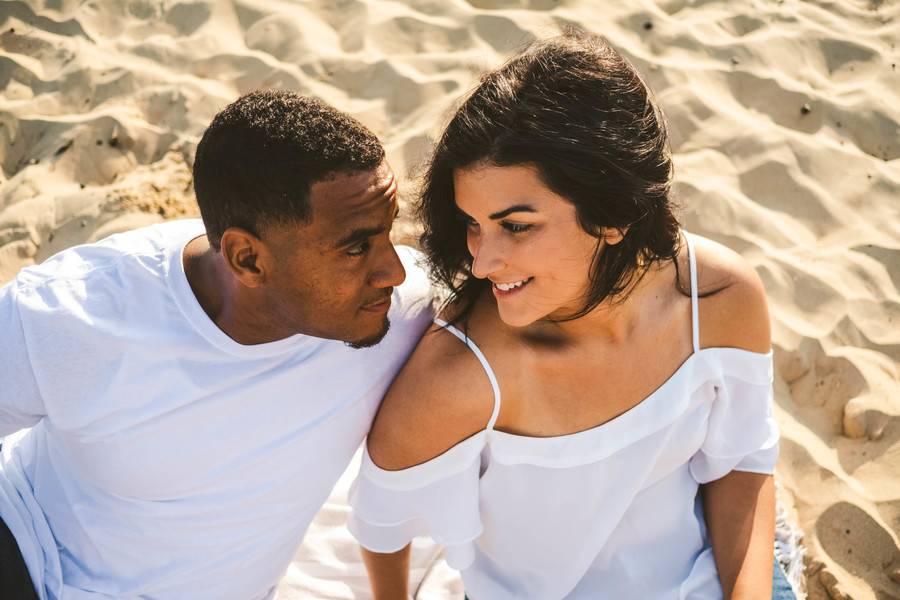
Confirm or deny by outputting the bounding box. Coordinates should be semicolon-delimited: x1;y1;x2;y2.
0;220;432;600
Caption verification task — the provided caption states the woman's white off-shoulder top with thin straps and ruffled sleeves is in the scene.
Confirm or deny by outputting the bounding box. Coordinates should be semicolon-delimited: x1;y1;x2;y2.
350;235;778;600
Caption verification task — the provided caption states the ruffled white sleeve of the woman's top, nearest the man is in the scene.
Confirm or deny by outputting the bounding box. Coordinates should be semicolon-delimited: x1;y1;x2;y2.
348;431;486;570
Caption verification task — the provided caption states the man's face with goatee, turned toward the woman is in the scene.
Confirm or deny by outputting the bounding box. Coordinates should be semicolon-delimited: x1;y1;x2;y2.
263;162;406;347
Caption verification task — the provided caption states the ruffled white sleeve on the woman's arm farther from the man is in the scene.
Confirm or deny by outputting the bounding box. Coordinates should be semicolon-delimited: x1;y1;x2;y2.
690;348;779;483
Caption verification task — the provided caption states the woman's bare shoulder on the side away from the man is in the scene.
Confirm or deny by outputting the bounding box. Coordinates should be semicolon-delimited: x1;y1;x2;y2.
693;236;772;353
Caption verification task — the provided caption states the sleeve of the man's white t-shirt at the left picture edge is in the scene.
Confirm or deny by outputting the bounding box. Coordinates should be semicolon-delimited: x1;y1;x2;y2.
0;280;45;437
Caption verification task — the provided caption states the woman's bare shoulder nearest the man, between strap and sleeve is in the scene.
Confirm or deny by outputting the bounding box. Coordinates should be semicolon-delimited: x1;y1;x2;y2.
368;325;494;471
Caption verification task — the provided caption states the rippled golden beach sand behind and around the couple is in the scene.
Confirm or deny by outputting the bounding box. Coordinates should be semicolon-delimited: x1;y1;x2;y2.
0;0;900;598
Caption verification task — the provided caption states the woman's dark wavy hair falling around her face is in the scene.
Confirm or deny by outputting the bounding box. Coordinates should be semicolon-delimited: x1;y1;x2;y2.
418;31;680;322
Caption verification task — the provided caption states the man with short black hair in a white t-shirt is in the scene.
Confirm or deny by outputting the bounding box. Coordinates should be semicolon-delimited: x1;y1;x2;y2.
0;91;431;600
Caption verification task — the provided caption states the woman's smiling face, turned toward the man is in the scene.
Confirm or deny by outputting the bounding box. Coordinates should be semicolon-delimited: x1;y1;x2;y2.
453;165;603;327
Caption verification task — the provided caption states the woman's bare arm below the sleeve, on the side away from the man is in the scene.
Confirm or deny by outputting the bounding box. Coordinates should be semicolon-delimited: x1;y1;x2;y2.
700;471;775;600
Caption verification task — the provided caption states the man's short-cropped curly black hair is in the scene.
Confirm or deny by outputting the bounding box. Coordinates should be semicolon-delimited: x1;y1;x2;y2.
194;90;384;250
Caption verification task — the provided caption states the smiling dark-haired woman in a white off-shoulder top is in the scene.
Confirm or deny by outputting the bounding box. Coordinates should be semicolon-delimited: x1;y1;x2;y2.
351;34;792;600
